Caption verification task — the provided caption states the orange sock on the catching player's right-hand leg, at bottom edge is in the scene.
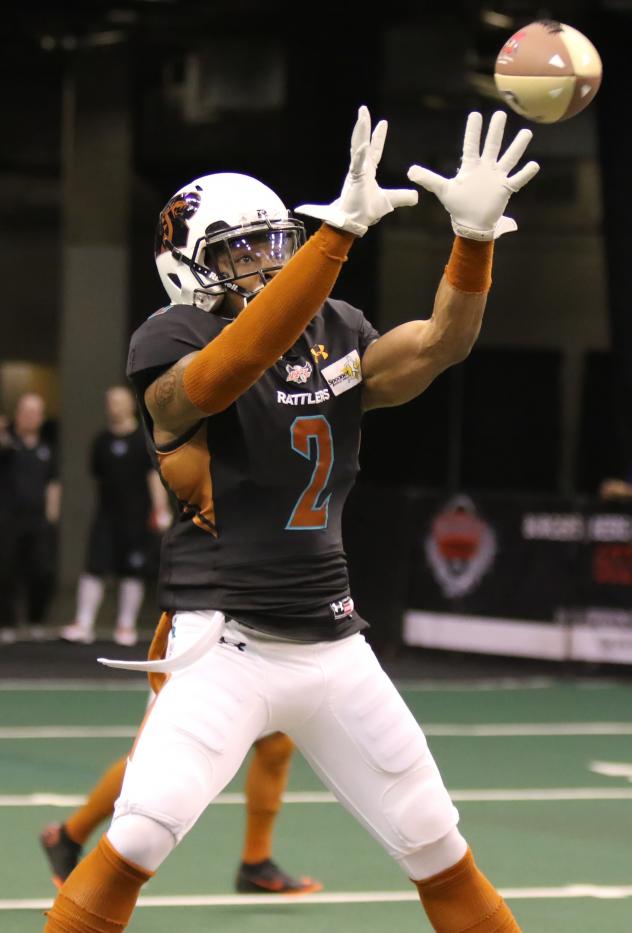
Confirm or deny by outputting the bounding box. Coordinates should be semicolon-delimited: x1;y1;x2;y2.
415;849;520;933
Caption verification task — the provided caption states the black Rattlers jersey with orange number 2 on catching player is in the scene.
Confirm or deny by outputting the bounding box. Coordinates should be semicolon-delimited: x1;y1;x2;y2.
128;299;378;641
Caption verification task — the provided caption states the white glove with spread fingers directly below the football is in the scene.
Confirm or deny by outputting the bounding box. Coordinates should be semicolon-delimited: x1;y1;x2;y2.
408;110;540;240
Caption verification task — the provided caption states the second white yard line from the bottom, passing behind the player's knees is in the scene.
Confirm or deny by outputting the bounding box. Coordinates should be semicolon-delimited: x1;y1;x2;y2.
0;787;632;807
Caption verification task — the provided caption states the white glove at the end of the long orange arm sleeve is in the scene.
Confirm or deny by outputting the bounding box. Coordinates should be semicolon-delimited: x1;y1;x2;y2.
295;106;419;236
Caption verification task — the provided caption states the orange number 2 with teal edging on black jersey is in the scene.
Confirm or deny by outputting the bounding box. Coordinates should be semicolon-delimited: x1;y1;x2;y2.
285;415;334;531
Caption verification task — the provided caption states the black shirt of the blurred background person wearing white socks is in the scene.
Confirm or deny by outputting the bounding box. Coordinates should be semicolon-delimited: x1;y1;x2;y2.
90;426;153;523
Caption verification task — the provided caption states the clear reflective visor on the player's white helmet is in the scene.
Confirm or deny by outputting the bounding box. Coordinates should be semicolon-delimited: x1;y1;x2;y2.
203;229;301;282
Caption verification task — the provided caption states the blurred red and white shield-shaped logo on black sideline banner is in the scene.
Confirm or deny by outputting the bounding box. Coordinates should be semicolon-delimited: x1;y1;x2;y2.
425;496;496;599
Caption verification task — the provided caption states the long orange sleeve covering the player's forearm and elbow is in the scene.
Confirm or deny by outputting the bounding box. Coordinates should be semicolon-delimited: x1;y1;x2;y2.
183;224;354;415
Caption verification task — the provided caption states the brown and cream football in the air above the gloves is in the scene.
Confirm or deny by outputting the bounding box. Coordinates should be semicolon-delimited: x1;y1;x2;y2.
494;20;602;123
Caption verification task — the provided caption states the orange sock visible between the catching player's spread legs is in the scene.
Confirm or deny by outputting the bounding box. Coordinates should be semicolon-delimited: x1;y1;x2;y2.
242;732;294;864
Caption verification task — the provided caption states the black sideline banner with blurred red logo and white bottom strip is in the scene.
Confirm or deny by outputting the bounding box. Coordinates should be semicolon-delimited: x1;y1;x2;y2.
349;486;632;663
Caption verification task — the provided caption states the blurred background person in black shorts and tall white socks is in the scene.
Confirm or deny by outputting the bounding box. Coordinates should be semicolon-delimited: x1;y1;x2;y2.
60;386;172;645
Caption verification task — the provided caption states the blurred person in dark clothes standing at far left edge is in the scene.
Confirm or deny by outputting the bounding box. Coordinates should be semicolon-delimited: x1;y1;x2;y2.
0;392;61;643
